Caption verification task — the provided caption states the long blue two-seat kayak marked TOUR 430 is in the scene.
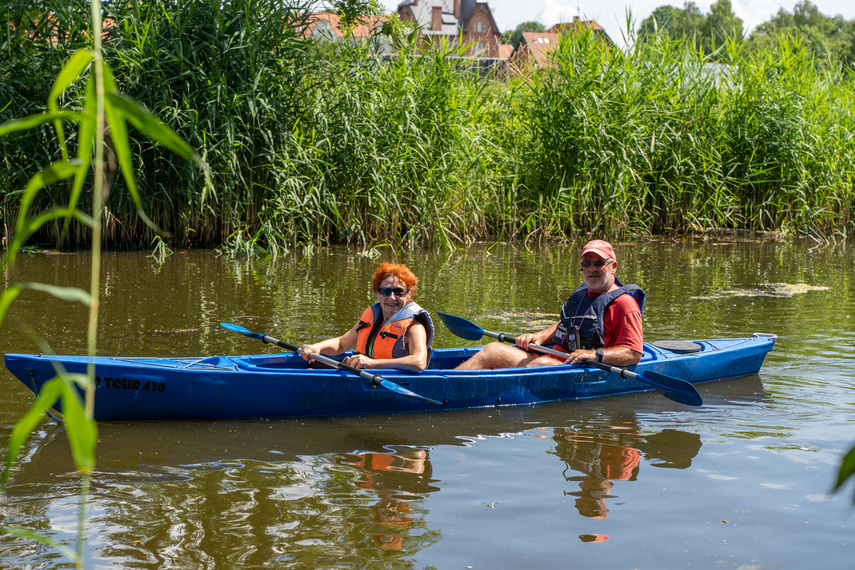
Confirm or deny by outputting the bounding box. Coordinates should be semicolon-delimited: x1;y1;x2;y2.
5;334;775;421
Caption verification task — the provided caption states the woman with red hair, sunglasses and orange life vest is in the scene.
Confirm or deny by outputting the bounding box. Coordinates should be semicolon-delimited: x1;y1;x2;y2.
300;263;433;372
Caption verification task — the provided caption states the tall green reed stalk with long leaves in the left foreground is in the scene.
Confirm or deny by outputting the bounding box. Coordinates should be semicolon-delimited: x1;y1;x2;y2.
0;0;207;568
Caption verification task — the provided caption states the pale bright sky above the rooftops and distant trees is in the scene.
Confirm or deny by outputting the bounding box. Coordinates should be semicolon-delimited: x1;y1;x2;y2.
382;0;855;45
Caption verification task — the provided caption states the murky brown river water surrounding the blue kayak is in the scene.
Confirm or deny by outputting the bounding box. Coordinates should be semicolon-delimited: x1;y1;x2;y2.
0;240;855;569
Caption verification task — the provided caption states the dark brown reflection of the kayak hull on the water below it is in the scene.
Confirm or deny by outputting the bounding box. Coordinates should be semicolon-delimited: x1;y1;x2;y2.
15;375;769;486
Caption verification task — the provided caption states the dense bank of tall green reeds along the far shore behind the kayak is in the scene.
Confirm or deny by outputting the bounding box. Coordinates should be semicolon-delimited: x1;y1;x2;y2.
0;0;855;253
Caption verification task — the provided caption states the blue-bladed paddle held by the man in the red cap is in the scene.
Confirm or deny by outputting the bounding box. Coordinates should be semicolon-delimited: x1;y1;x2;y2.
437;311;704;406
